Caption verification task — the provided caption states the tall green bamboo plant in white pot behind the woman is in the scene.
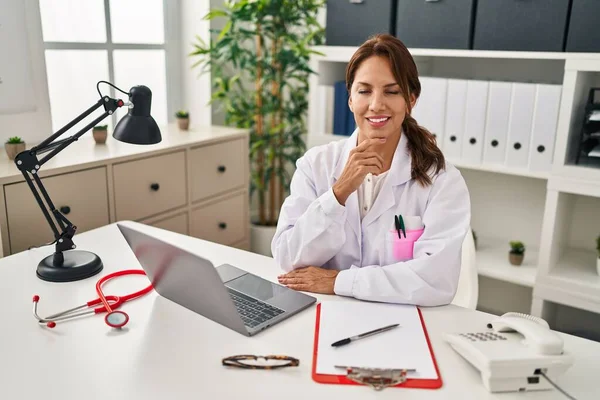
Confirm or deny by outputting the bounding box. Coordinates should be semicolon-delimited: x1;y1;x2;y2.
190;0;324;255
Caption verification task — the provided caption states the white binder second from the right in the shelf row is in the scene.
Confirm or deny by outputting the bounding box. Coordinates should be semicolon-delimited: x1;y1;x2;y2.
506;83;536;168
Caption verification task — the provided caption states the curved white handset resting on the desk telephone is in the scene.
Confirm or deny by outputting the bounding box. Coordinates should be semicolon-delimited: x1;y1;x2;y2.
488;312;563;355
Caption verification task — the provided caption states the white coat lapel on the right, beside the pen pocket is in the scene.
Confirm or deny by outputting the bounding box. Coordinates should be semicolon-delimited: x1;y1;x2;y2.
363;133;412;226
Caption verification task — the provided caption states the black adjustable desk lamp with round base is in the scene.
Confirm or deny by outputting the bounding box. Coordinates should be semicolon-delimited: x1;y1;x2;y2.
15;81;161;282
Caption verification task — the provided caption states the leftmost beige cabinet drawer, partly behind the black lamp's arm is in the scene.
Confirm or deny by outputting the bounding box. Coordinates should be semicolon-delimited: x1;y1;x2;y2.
4;167;109;253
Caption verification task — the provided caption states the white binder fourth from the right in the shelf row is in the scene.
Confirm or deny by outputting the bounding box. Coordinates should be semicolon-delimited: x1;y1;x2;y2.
462;80;489;164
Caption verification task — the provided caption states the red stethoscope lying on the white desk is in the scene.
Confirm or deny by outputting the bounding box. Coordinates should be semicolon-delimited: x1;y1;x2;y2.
33;269;153;328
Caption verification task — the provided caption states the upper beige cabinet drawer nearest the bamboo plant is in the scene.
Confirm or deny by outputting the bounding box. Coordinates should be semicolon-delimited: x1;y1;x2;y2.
190;140;243;201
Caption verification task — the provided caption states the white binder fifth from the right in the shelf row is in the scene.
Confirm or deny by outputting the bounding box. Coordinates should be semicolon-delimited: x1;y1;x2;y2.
443;79;467;160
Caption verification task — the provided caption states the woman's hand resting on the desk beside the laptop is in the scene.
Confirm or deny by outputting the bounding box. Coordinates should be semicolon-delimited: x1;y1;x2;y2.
277;267;340;294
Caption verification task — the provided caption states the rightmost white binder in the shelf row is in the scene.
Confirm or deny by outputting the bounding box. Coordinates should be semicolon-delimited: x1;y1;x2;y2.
529;84;562;172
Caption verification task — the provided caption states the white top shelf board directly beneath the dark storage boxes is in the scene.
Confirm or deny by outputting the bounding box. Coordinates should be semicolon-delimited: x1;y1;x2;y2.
313;46;600;62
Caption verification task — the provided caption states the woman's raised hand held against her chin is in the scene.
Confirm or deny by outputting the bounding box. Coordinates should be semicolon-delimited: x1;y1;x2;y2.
333;139;384;205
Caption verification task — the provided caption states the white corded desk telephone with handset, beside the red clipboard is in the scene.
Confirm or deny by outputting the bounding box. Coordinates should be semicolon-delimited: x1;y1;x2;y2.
444;312;573;392
